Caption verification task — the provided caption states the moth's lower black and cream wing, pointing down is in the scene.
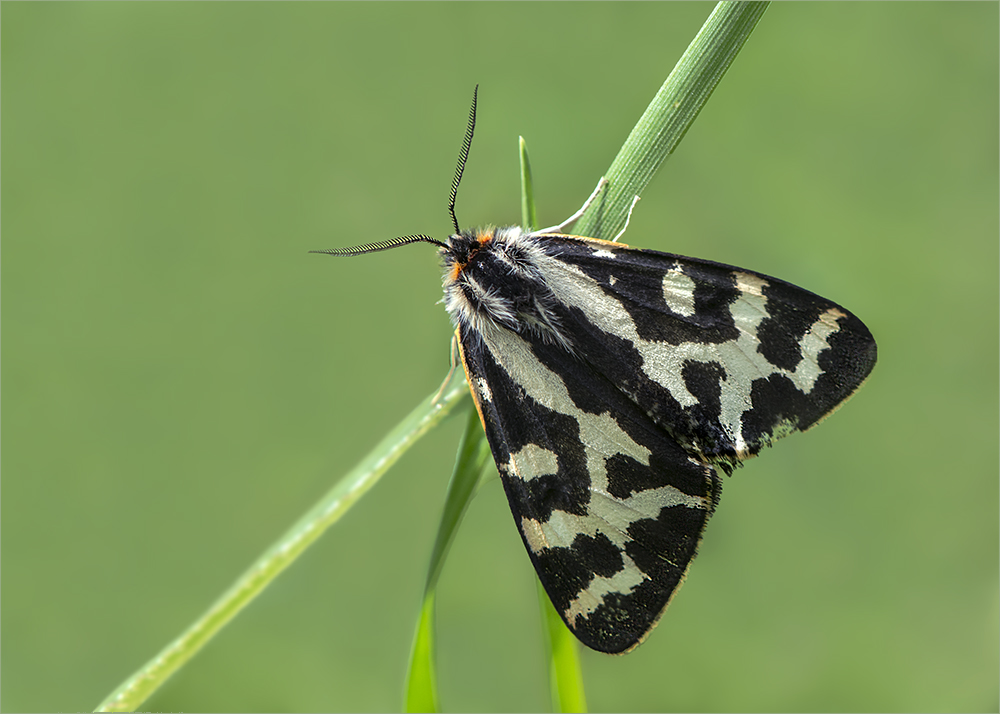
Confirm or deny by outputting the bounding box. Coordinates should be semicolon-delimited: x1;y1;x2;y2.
461;331;719;653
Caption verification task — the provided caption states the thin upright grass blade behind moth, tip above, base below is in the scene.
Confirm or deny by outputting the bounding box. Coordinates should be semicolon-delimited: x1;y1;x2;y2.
518;137;587;712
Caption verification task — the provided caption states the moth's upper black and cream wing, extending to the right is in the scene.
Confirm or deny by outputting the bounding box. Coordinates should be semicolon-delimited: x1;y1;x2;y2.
540;236;876;468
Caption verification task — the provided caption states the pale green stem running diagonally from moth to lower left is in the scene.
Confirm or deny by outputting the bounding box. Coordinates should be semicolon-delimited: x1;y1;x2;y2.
97;379;469;711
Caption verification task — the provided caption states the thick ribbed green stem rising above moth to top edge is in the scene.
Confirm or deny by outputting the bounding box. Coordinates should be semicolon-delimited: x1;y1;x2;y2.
573;2;768;242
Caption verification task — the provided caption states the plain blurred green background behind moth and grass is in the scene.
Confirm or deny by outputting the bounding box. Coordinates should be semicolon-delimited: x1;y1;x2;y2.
0;3;1000;711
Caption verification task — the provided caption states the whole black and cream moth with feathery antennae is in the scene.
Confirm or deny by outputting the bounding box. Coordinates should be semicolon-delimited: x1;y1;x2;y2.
314;88;876;653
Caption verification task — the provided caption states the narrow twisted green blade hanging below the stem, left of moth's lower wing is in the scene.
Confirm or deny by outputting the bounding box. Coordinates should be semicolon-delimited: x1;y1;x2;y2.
405;409;490;712
